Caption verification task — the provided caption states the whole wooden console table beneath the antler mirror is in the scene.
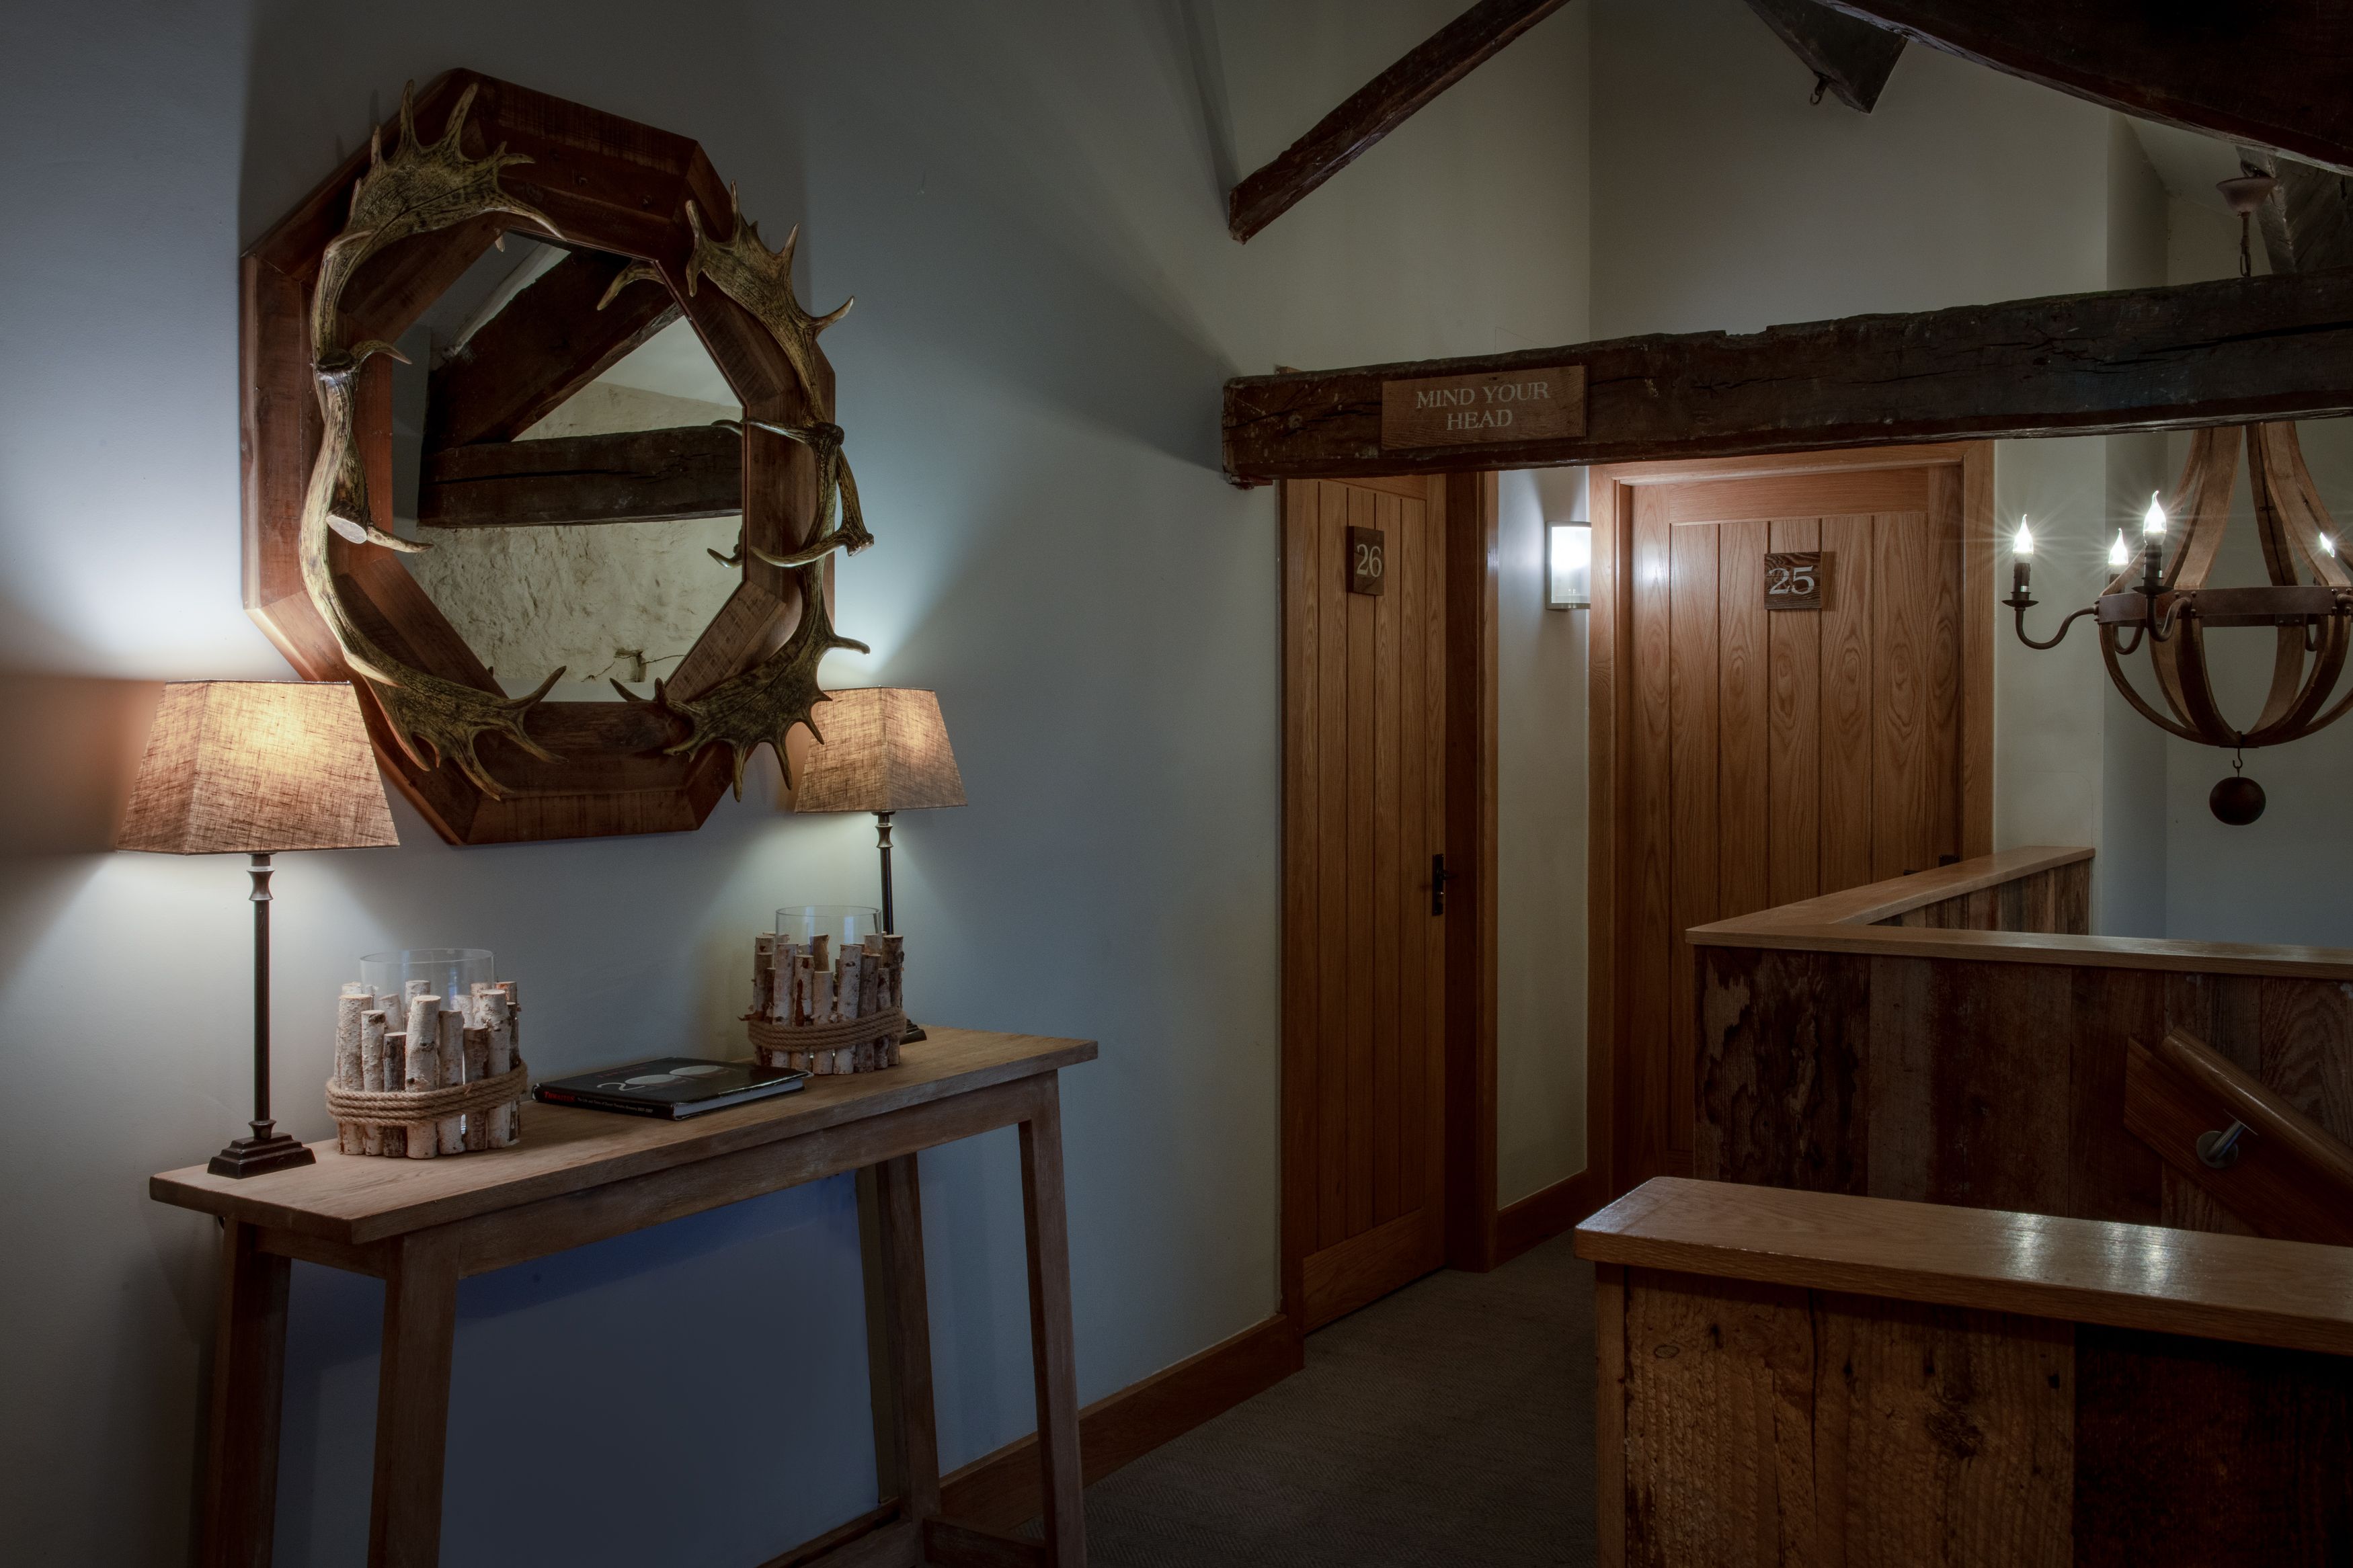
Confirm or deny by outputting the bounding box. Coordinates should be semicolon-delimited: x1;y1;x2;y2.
149;1028;1094;1568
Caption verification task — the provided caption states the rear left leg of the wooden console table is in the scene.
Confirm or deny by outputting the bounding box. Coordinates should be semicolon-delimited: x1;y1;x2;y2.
198;1220;292;1568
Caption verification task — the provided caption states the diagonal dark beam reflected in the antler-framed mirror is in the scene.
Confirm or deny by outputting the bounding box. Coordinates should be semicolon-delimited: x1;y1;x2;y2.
426;251;678;449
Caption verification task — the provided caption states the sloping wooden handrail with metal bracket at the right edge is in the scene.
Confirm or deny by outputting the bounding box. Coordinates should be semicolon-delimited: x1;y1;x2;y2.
2125;1030;2353;1246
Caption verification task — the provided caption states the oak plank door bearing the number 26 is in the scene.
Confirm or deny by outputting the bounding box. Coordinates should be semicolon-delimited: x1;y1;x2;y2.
1283;480;1468;1328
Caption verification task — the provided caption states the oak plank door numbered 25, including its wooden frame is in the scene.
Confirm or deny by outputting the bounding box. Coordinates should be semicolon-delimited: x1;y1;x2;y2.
1593;442;1993;1190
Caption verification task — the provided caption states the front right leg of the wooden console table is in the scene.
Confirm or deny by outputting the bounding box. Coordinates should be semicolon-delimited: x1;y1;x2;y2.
1021;1072;1087;1568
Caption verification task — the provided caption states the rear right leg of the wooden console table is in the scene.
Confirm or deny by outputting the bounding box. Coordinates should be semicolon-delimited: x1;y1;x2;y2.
859;1154;939;1521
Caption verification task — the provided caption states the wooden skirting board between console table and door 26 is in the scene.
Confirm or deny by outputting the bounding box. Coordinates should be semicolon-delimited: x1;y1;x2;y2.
941;1314;1306;1530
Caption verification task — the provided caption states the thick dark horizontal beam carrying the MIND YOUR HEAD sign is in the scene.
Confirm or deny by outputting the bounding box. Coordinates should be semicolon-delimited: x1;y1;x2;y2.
1226;270;2353;482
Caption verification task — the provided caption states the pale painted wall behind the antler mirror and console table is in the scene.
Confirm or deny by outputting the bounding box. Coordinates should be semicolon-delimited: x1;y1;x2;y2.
0;0;1586;1563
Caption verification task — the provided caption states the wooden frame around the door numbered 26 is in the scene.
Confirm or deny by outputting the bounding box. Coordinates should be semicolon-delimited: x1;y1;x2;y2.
1278;472;1501;1323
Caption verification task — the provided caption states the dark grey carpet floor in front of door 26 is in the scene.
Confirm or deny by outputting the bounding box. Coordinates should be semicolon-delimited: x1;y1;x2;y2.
1068;1237;1593;1568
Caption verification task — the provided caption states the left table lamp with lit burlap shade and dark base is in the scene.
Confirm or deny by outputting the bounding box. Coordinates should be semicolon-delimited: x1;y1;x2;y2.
116;682;400;1175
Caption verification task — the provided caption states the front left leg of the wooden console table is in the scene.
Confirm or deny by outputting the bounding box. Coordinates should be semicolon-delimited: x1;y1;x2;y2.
367;1229;456;1568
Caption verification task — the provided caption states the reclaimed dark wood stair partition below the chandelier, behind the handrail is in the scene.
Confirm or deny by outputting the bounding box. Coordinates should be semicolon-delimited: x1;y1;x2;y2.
1689;849;2353;1229
